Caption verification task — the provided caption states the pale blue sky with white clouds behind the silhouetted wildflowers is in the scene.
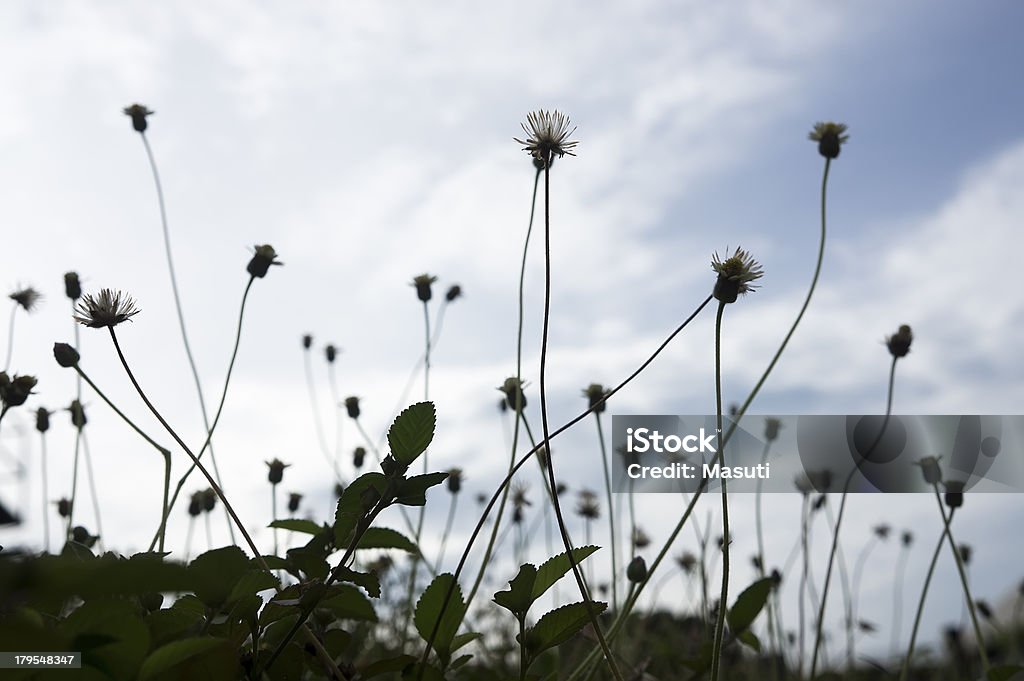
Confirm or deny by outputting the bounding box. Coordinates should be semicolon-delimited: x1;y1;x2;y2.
0;0;1024;667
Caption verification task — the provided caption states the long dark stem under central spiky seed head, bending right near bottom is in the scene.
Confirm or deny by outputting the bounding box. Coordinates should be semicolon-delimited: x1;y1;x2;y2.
540;159;624;681
